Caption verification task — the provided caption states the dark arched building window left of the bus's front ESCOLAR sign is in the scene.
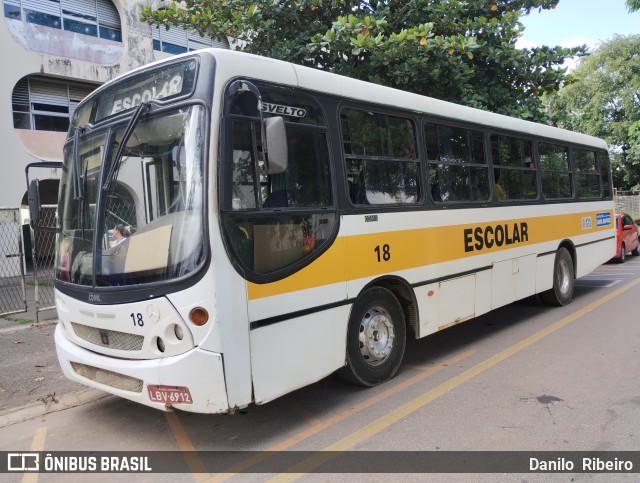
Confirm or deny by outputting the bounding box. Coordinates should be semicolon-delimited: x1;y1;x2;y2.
11;76;96;132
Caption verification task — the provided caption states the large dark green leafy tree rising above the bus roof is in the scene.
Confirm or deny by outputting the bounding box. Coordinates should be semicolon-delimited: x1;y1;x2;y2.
141;0;587;121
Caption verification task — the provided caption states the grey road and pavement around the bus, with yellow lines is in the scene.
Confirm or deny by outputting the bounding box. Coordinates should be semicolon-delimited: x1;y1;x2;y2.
0;257;640;482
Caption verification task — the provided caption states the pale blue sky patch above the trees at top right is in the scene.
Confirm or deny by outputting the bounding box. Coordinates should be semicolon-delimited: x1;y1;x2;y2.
517;0;640;50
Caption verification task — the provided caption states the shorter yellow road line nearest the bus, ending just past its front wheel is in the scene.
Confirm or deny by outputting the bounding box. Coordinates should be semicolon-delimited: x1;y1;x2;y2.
207;349;476;483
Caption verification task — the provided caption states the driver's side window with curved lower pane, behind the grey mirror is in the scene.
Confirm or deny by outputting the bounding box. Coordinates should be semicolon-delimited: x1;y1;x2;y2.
225;112;336;274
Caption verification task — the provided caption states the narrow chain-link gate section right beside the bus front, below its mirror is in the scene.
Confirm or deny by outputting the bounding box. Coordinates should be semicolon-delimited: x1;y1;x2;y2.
32;206;56;318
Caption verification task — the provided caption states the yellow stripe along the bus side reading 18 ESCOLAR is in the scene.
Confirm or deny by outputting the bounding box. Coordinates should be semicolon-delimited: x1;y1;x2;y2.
248;210;614;300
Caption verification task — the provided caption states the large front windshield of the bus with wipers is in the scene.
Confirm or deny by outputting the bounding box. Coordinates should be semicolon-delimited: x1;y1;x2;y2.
55;106;206;287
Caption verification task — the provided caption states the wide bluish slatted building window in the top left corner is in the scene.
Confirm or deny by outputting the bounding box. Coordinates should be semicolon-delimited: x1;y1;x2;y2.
4;0;122;42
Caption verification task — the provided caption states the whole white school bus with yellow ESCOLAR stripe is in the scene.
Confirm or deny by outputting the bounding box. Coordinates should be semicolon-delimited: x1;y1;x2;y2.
35;49;615;413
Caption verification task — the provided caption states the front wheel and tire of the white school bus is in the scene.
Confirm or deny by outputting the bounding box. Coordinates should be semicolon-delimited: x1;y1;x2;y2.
338;287;407;387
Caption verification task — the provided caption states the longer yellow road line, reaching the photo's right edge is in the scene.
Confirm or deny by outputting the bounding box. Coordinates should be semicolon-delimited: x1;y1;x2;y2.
269;279;640;482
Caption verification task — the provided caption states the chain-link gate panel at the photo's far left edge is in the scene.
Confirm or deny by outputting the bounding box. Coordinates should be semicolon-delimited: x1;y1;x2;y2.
0;208;27;315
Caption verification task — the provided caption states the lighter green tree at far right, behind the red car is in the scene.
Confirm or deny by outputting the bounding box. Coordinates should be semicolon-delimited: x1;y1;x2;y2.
549;35;640;189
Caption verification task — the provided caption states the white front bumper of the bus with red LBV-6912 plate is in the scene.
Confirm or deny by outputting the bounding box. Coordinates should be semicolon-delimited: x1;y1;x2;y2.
55;323;229;413
